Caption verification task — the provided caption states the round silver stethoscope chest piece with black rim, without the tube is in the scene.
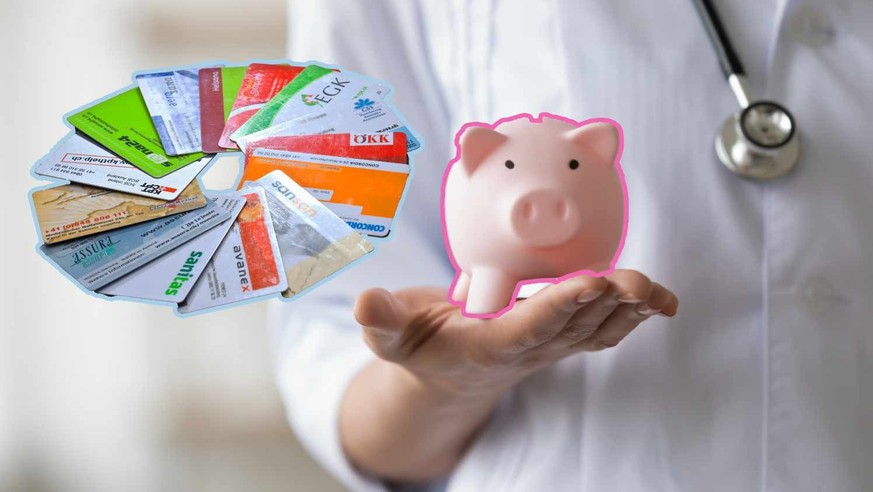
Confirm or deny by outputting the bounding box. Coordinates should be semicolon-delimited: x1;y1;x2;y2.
715;101;800;181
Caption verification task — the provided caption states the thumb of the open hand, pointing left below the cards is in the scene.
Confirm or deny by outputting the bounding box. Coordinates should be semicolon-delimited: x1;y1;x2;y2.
354;288;411;361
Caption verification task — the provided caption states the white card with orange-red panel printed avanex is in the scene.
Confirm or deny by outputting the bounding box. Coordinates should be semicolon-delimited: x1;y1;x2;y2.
178;189;288;314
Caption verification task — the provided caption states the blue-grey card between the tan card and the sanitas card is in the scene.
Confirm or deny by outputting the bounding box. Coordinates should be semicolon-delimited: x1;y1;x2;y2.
40;202;230;291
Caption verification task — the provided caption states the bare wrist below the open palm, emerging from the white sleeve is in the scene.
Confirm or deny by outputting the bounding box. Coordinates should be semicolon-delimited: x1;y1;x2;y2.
339;359;505;481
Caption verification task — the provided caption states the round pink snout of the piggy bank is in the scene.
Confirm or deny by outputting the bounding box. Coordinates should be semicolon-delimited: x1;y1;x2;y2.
510;190;582;247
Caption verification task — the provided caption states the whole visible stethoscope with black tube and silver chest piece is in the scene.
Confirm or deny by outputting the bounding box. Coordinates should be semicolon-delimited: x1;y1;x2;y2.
693;0;800;181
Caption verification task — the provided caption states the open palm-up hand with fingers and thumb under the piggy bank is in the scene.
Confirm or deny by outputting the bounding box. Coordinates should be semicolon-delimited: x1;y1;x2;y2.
355;270;678;396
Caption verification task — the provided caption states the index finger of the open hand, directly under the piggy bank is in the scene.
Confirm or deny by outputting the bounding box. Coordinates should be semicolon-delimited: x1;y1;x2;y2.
493;275;609;353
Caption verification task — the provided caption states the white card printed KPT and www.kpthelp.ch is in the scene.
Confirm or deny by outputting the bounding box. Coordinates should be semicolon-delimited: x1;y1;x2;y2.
33;133;212;200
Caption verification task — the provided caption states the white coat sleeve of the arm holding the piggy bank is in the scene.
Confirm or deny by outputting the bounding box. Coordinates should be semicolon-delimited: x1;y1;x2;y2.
273;0;454;491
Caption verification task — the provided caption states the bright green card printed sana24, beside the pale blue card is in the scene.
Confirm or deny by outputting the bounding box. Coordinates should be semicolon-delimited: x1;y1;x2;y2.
67;87;206;178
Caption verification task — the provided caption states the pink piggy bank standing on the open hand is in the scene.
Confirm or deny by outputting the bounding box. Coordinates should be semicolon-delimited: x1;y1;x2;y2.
442;113;627;317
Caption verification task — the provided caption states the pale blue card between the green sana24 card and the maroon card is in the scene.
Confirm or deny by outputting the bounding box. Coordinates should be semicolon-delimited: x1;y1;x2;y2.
135;70;201;155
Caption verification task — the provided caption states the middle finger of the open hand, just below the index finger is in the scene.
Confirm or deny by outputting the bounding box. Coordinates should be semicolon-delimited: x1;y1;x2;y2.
552;270;653;348
